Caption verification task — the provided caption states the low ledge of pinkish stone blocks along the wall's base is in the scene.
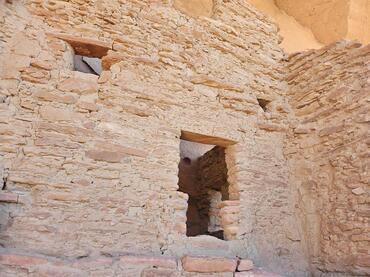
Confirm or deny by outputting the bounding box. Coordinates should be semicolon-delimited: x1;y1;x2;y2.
0;249;284;277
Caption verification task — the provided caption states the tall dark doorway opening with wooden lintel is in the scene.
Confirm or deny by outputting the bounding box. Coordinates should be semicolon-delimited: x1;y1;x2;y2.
178;132;235;239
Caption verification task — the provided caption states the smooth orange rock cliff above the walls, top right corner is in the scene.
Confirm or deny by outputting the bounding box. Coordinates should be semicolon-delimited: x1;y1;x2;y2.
248;0;370;53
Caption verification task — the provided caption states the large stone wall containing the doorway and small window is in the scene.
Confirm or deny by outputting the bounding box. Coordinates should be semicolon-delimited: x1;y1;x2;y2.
0;0;307;276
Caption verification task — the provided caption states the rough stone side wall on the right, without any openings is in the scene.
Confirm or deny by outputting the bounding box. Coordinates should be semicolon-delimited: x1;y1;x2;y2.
285;41;370;276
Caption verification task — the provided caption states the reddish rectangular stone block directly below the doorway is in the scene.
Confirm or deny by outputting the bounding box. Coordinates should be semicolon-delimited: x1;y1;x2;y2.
181;256;237;273
